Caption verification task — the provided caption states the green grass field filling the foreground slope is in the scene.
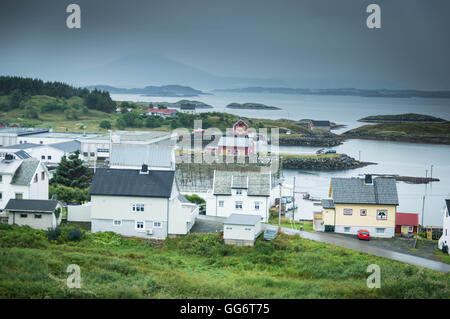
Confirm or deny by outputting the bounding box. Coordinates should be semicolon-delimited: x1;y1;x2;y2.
0;225;450;298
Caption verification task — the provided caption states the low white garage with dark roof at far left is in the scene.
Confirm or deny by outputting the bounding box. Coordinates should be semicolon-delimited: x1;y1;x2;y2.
5;199;62;230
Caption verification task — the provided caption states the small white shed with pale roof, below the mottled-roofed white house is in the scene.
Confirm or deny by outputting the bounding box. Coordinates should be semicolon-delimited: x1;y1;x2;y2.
223;214;262;246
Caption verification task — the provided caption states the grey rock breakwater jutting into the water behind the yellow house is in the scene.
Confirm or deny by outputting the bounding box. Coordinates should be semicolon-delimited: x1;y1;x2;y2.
282;154;376;171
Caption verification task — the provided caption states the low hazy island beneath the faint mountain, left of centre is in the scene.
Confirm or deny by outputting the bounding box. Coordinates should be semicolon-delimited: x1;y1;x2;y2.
88;85;208;97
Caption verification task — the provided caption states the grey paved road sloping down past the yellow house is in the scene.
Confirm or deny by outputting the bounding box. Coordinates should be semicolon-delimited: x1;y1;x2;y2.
265;225;450;272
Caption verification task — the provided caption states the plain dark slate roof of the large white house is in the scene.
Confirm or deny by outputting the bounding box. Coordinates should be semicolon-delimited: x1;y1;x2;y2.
89;168;175;198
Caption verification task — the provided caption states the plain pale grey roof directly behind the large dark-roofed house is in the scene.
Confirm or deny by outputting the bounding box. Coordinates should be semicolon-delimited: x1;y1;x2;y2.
109;144;173;168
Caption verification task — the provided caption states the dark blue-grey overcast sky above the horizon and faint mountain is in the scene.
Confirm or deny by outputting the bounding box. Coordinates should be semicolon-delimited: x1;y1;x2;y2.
0;0;450;90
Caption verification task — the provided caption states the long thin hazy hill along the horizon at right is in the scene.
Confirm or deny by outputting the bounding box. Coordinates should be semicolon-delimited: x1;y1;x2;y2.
213;87;450;98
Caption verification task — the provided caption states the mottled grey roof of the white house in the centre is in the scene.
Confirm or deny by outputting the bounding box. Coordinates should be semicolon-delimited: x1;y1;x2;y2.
214;171;271;196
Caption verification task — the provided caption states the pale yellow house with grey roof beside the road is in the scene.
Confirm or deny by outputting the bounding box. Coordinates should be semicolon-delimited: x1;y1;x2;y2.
322;175;398;237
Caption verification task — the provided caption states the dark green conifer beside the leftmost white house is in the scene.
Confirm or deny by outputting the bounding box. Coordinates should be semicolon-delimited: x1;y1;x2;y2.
50;151;93;189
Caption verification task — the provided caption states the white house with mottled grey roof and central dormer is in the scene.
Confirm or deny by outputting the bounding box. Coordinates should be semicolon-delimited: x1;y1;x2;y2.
206;171;272;222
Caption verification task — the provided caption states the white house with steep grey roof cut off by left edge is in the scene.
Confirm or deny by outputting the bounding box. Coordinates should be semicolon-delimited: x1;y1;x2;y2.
0;154;49;217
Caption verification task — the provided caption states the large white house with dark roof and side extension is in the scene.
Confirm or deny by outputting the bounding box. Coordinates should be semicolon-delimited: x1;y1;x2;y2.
89;165;198;239
